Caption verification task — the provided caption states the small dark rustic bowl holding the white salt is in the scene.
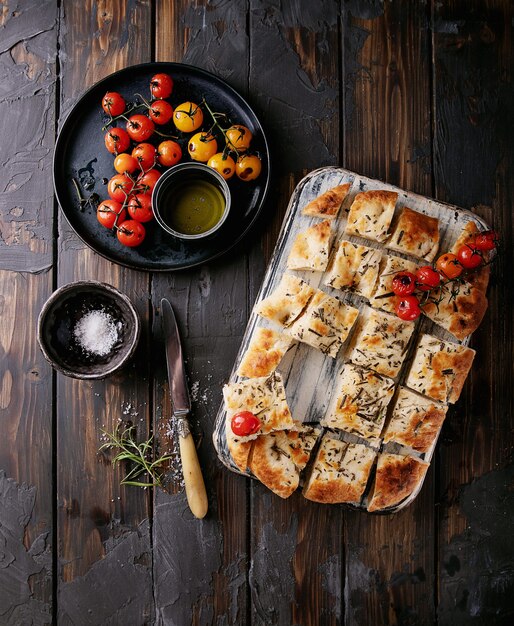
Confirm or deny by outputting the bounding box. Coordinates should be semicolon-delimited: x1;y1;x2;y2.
38;281;141;380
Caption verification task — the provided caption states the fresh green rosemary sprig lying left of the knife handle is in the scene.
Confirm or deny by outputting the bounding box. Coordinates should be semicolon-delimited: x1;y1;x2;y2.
99;424;172;488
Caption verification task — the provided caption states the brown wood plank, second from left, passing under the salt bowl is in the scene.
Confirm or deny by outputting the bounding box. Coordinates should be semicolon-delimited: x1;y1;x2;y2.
57;0;153;623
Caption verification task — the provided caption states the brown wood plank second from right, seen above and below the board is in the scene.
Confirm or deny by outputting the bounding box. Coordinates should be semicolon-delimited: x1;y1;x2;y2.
343;1;435;624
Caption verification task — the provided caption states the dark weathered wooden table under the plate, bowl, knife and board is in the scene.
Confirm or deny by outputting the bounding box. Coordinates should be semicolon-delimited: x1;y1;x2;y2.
0;0;514;626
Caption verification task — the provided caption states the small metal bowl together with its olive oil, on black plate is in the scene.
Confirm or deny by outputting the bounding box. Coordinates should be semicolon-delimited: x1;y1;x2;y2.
152;163;230;239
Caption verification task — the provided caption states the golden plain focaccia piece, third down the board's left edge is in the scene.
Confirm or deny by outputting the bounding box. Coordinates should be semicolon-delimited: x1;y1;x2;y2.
255;274;316;326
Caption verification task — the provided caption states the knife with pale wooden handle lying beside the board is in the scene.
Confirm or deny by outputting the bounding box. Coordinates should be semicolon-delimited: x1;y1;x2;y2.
161;298;208;519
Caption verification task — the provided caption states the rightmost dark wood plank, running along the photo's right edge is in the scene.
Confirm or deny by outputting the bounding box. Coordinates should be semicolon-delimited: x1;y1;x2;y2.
433;1;514;624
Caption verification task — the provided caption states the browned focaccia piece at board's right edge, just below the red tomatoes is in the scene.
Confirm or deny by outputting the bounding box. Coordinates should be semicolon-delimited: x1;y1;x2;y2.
421;282;487;340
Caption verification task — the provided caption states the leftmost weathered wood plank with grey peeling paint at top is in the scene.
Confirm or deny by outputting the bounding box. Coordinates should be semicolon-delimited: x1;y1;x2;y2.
0;2;57;624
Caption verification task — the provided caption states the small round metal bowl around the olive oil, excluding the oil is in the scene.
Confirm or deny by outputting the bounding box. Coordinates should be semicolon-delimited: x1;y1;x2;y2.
152;162;231;240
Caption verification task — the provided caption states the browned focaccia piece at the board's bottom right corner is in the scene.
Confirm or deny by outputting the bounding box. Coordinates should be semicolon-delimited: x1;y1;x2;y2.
368;453;429;511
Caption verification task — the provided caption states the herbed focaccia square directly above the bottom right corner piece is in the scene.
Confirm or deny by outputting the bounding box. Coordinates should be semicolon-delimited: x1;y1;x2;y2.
384;387;448;453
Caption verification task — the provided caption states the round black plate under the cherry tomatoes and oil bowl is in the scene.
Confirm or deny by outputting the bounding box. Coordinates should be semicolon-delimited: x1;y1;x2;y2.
54;63;270;271
